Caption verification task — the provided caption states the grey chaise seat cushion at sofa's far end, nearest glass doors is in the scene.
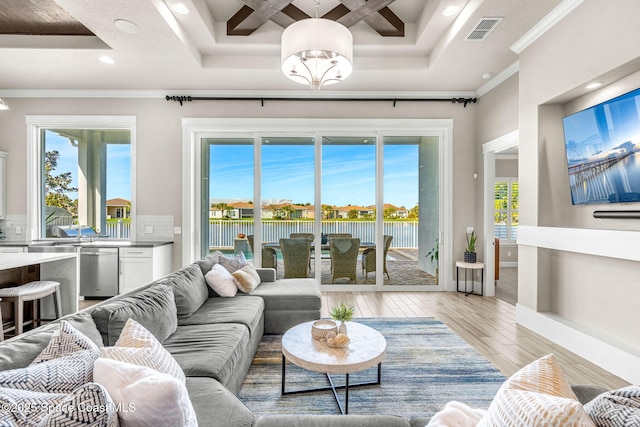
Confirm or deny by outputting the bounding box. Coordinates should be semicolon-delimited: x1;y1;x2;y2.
248;279;322;311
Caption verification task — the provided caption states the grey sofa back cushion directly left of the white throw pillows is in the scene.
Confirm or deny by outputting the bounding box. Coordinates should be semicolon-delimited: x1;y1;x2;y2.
158;264;209;319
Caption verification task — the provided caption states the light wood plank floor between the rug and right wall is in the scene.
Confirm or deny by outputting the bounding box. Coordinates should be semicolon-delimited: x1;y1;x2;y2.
322;292;629;389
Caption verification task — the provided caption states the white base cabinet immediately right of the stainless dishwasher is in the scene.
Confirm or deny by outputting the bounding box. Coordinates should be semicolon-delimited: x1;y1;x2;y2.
118;244;173;293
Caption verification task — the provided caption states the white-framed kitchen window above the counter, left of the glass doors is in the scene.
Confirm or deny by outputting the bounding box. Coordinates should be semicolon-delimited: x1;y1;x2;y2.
27;116;135;239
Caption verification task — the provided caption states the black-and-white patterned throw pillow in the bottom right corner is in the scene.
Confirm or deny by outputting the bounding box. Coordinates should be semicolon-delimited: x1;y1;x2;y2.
584;385;640;427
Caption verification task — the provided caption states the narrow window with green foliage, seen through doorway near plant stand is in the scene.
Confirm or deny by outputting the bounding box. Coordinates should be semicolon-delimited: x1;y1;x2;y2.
493;178;518;243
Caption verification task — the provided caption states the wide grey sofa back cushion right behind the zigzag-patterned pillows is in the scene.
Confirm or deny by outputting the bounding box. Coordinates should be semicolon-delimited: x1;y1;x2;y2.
92;284;178;346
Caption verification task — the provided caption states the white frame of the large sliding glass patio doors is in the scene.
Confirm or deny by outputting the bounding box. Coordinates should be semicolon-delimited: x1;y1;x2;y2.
182;118;455;291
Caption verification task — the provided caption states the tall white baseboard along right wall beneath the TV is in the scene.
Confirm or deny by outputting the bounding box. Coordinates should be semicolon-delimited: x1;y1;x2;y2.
516;304;640;384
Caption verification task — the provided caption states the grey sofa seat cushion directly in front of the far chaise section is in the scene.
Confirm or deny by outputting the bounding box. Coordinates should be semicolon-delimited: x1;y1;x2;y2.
178;297;264;334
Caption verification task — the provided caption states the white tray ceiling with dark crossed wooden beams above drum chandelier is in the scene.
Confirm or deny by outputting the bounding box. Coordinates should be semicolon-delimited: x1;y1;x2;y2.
0;0;567;96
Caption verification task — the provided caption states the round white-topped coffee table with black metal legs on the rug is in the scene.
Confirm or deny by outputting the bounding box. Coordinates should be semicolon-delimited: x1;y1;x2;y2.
282;322;387;414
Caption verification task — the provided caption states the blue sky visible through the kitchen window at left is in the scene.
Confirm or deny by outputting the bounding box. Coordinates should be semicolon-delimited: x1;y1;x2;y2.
45;131;131;200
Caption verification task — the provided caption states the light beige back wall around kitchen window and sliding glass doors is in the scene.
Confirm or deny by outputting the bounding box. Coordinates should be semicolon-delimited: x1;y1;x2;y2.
0;97;477;274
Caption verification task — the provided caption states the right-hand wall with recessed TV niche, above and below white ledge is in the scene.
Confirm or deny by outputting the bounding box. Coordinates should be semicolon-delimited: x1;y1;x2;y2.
518;0;640;379
